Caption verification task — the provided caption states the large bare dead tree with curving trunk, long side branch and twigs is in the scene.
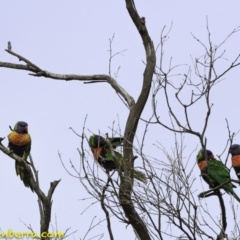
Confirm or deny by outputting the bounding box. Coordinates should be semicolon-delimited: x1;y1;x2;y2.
0;0;240;240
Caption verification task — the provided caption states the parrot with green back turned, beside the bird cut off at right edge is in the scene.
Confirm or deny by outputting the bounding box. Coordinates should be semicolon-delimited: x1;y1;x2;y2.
197;150;240;202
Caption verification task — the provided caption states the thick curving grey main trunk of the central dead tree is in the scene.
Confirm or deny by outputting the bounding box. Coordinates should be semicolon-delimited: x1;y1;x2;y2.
119;0;156;240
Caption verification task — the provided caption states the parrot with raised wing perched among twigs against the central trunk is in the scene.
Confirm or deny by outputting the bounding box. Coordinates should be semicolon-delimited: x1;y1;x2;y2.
89;135;146;183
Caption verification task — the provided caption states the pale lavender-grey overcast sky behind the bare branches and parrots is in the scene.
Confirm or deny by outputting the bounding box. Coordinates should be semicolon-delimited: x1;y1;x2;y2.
0;0;240;240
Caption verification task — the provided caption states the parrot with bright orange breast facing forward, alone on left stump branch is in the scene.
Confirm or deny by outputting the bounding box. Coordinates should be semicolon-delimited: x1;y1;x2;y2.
8;121;34;192
